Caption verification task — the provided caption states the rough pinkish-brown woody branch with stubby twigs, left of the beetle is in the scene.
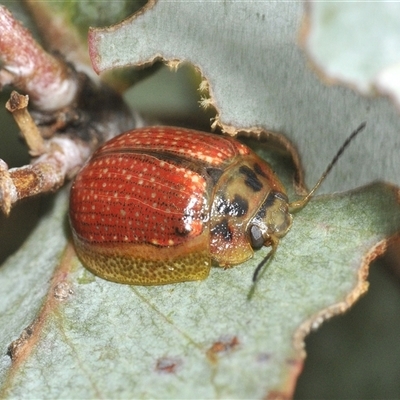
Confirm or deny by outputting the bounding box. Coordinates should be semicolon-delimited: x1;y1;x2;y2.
0;6;134;214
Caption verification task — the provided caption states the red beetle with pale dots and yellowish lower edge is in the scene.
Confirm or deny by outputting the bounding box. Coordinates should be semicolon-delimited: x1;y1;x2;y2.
69;124;365;285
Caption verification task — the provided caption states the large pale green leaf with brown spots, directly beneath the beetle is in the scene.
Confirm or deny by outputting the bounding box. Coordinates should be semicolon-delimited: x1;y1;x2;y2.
0;150;400;398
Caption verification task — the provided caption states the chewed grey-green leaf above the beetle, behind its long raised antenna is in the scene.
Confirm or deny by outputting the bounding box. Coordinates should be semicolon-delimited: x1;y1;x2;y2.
89;0;400;192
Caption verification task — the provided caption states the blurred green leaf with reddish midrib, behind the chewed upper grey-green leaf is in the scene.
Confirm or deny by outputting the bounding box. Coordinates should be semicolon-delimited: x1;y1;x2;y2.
21;0;158;91
